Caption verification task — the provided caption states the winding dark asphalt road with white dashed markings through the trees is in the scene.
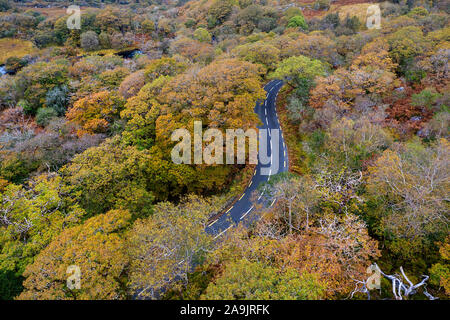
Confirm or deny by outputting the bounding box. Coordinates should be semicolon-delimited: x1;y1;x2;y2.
206;80;289;238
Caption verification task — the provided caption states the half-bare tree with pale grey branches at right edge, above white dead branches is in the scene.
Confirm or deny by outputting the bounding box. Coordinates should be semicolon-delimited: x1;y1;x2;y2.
368;138;450;268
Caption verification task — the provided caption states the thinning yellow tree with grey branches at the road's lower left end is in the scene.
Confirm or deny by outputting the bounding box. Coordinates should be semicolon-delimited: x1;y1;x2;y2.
128;196;214;298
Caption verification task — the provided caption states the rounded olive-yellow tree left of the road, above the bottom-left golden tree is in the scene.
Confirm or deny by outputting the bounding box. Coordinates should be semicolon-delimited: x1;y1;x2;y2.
62;138;155;215
